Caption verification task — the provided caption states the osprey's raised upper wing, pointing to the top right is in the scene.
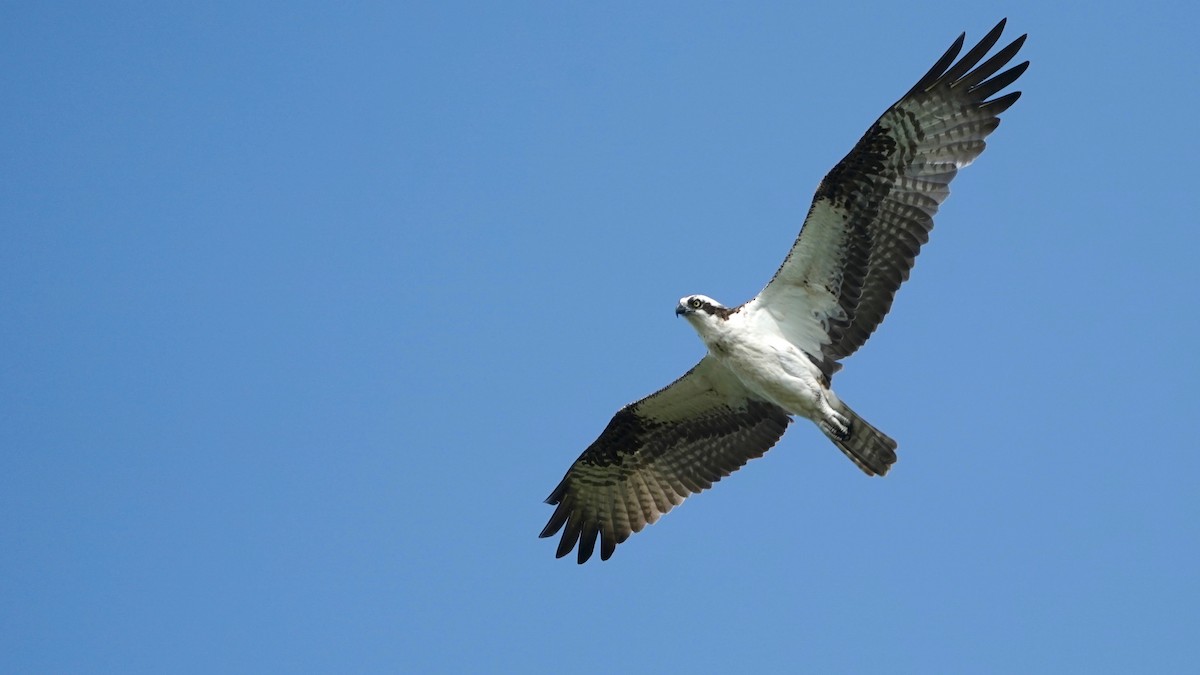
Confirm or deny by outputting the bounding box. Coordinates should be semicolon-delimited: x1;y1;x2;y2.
751;20;1028;375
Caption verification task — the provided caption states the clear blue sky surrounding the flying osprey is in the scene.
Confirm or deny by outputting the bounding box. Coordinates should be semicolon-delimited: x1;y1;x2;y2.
0;1;1200;673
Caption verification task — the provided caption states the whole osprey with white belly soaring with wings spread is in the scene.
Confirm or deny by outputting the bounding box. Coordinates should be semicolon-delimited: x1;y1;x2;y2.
541;20;1030;563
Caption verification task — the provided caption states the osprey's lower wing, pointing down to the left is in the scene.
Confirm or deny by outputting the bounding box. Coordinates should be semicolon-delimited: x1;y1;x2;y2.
540;356;791;563
